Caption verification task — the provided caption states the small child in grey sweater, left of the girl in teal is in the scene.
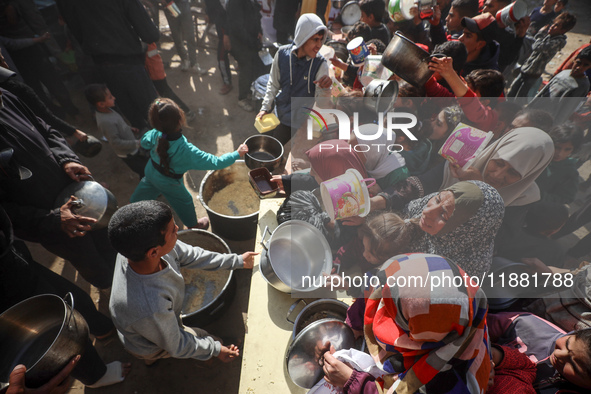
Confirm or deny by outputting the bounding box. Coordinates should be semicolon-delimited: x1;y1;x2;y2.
84;84;148;179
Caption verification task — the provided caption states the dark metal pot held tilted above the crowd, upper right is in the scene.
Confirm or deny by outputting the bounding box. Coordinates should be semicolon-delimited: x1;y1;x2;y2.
382;31;433;87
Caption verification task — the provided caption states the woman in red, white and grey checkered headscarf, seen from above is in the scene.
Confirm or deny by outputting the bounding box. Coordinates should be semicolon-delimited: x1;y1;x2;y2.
323;254;491;394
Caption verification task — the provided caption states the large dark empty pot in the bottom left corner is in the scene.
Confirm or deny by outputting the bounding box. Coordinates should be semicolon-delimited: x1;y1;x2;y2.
0;293;88;388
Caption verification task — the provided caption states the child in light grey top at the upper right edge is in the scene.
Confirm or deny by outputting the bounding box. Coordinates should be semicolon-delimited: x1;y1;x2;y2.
529;47;591;124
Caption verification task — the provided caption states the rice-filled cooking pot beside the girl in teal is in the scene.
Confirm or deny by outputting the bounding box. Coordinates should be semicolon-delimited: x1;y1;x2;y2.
199;160;260;241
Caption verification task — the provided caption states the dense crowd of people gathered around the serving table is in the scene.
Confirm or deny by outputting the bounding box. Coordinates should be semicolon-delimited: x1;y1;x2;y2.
0;0;591;394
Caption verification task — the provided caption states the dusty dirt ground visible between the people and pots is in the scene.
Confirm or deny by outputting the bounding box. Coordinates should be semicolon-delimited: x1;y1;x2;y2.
23;0;591;394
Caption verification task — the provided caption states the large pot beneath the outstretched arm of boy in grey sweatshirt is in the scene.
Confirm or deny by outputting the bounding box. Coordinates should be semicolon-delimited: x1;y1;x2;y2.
178;229;236;326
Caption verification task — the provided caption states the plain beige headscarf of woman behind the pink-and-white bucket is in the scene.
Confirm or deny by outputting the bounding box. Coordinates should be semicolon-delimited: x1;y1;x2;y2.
439;127;554;207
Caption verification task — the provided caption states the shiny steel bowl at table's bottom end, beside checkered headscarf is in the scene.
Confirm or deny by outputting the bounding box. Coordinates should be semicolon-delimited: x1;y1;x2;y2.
285;319;355;389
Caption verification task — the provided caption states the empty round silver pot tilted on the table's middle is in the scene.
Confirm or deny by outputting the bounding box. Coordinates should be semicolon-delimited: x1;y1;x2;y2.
259;220;332;293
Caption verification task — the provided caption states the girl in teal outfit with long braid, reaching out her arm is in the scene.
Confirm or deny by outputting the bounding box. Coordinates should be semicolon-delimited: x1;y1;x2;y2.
130;98;248;229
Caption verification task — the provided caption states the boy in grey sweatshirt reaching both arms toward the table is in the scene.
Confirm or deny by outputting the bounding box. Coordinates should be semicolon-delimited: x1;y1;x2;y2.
109;201;255;365
